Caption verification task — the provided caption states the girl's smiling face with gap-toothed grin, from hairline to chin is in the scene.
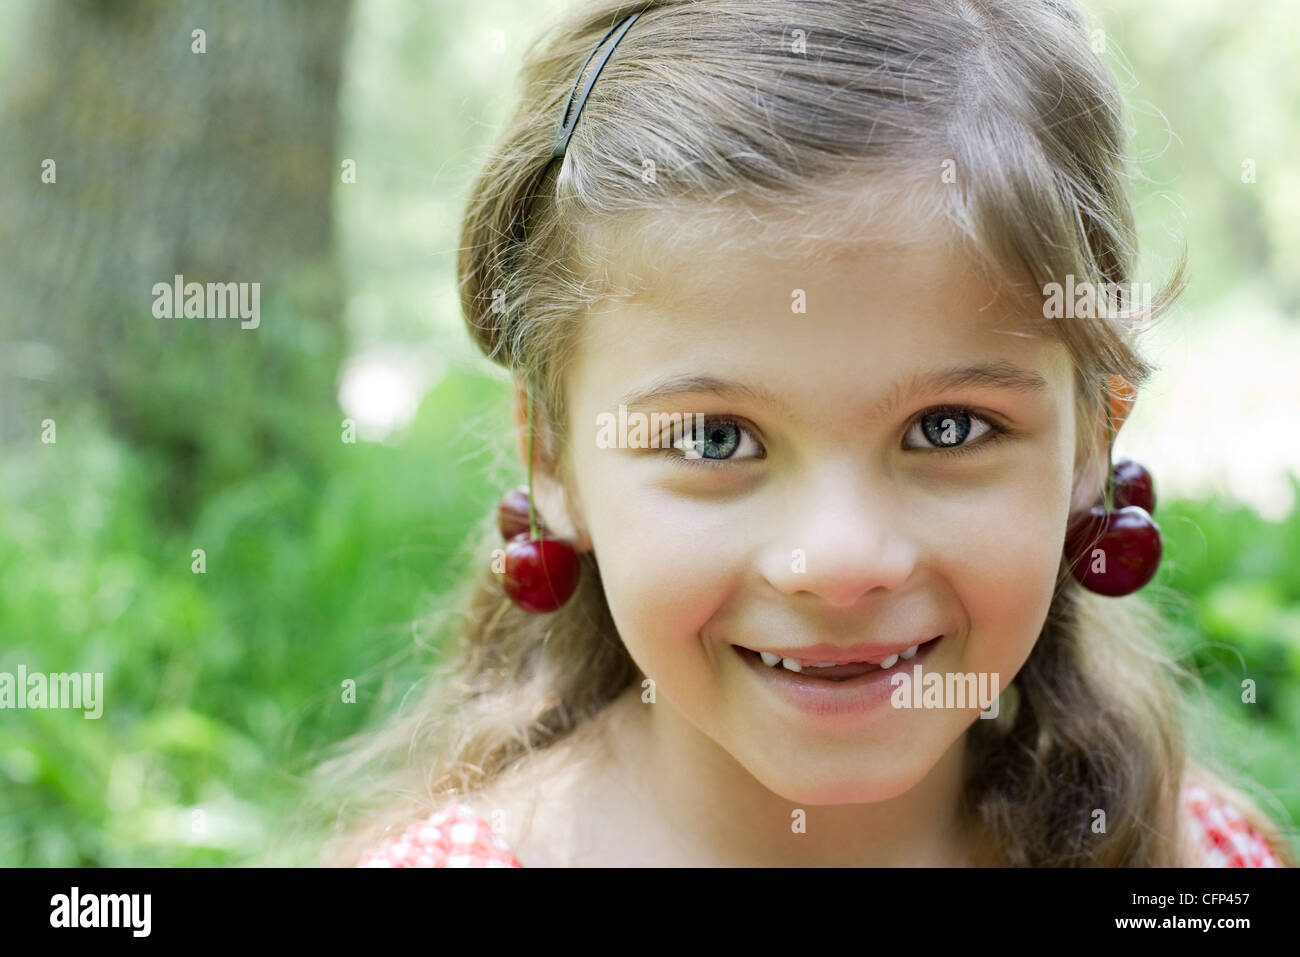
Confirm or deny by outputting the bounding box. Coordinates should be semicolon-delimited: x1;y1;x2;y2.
548;218;1075;805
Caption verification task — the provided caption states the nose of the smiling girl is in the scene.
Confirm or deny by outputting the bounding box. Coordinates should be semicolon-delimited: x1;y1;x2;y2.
761;468;918;607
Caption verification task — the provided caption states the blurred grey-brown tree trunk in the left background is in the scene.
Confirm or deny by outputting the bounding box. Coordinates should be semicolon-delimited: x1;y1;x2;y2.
0;0;348;514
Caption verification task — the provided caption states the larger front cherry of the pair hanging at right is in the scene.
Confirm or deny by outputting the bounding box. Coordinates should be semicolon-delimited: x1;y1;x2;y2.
1066;505;1164;598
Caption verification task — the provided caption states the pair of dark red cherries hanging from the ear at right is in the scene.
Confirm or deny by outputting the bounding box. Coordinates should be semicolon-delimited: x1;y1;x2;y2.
1065;459;1162;598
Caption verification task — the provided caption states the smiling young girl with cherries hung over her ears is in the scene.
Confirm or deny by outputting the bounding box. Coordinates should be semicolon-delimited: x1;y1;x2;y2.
314;0;1294;866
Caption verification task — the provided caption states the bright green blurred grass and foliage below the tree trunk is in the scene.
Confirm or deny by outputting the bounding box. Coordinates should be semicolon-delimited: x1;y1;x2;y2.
0;374;507;866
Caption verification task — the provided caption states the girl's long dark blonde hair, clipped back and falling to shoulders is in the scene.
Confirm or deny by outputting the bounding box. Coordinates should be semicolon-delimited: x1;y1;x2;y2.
301;0;1294;866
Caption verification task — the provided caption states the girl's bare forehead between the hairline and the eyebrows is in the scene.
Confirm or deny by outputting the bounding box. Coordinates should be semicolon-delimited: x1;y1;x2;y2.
573;234;1070;407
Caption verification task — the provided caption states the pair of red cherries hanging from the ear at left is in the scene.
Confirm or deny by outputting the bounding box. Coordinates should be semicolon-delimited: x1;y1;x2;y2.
497;485;579;614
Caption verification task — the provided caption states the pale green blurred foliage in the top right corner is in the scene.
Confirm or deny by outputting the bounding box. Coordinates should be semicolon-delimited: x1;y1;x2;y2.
1102;0;1300;310
